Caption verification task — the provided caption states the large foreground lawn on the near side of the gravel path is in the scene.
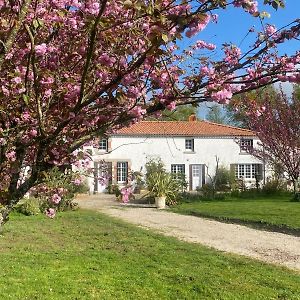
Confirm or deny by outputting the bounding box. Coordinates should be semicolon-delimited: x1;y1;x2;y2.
0;211;300;300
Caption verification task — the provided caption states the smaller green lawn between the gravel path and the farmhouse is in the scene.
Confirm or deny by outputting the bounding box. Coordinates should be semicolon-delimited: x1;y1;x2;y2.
172;196;300;235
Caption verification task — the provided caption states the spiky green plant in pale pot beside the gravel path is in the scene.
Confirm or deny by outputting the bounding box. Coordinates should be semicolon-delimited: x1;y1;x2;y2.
147;172;179;209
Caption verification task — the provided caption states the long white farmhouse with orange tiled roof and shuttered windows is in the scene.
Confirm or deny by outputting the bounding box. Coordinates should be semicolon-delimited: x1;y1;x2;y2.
85;116;265;192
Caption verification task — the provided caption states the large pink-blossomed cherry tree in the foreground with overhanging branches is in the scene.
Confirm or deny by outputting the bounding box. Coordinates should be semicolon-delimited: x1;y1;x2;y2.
0;0;300;224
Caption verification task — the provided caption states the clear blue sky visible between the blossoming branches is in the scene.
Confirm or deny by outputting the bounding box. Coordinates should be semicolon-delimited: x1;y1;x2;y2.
180;0;300;118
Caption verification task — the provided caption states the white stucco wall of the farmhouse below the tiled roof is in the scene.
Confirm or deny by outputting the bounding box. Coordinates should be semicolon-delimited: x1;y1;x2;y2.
93;136;261;191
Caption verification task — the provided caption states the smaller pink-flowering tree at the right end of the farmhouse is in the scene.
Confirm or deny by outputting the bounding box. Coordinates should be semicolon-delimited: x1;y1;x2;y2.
239;91;300;193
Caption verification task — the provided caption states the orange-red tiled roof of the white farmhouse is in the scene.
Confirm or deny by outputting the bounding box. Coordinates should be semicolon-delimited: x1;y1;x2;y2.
114;121;255;137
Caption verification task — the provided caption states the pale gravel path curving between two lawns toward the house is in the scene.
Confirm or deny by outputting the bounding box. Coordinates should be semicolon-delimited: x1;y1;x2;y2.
78;195;300;270
